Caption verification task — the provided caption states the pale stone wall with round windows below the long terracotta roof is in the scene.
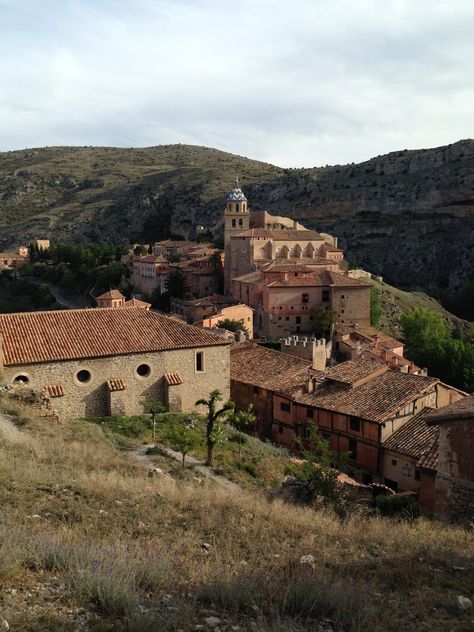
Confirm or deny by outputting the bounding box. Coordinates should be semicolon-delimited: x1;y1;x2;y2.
3;346;230;418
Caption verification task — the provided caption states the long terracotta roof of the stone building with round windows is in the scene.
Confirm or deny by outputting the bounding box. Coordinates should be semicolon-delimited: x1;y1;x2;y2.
0;308;229;366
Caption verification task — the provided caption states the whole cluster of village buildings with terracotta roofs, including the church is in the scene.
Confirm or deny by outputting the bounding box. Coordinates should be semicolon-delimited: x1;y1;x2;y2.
0;183;474;521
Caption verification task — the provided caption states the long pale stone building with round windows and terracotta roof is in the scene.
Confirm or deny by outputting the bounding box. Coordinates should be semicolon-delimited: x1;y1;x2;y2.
0;307;230;418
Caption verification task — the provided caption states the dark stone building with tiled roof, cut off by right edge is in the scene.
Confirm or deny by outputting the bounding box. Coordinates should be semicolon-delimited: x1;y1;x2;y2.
424;394;474;525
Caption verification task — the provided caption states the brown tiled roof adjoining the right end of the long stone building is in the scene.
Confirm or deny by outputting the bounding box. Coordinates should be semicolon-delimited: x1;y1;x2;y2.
230;342;316;394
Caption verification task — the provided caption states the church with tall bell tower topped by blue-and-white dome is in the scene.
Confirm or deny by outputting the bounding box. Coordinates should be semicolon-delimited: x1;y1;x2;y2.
224;179;347;294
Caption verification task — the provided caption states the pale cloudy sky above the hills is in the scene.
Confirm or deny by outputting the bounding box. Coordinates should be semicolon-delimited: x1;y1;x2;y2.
0;0;474;167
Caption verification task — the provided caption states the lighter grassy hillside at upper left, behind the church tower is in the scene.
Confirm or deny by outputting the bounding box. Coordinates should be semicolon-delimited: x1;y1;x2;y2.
0;145;283;227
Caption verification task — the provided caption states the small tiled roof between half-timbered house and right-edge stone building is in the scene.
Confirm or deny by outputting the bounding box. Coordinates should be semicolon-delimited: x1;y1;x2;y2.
383;408;438;460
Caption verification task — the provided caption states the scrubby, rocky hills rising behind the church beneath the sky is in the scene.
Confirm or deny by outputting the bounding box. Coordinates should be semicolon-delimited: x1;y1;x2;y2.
0;140;474;292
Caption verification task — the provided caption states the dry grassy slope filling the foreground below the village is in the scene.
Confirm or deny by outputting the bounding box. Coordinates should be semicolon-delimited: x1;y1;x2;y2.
0;396;474;632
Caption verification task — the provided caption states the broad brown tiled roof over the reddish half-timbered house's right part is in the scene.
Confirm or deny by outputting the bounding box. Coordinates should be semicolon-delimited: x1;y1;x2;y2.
296;370;439;423
